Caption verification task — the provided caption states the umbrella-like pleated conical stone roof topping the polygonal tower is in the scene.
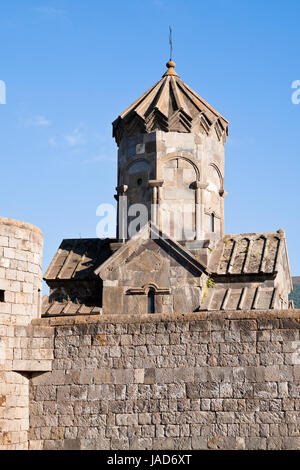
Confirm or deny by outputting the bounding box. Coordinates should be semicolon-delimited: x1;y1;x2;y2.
113;61;228;144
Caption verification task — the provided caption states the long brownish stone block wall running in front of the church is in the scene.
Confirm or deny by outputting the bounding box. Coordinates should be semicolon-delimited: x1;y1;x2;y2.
29;310;300;450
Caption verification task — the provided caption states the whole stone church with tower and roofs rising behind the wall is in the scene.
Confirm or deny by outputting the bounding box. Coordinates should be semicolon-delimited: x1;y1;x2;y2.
44;57;292;316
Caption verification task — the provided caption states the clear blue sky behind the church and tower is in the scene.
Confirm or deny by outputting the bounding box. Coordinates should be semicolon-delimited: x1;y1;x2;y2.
0;0;300;284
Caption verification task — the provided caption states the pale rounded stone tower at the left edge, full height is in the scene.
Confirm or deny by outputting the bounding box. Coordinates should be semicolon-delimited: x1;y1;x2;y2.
0;218;43;449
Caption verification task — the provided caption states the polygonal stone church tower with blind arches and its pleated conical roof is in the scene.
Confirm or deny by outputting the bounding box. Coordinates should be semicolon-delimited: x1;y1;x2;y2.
113;61;228;246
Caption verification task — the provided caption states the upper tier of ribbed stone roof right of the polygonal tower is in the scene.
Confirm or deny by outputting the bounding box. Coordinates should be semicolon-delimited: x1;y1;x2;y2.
208;230;286;276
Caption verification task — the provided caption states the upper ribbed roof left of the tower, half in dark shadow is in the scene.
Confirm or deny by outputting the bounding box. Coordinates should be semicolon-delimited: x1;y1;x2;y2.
44;238;115;281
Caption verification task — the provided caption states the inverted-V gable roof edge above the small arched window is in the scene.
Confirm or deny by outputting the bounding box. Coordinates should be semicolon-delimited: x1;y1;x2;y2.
95;222;207;280
